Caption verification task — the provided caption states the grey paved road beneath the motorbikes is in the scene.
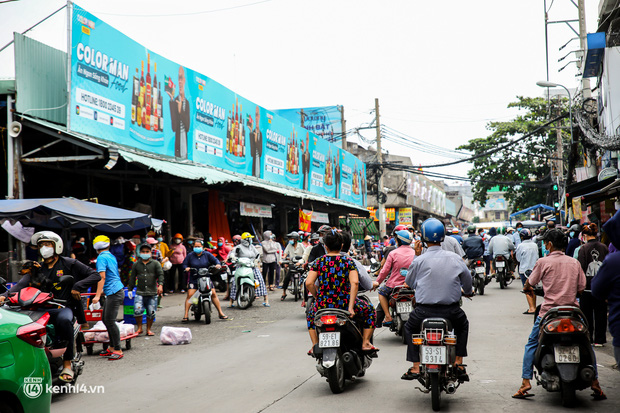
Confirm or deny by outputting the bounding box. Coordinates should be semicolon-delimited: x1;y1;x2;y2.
52;284;620;413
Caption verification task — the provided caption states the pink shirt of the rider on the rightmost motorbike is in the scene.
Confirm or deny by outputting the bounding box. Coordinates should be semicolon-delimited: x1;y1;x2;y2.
528;251;586;317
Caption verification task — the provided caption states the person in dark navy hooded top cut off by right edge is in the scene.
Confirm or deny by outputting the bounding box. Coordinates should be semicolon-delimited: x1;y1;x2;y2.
592;210;620;365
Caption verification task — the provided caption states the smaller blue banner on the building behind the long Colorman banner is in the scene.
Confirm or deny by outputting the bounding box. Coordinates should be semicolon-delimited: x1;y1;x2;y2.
274;106;342;147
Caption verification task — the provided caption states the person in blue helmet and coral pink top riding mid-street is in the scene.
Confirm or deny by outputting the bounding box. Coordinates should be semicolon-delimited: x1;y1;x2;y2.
373;229;416;327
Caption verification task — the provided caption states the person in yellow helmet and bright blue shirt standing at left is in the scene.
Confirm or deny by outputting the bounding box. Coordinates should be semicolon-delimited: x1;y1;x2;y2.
93;235;125;360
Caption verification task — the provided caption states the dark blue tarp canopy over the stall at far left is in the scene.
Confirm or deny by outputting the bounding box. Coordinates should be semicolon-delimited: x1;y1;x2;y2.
0;198;163;233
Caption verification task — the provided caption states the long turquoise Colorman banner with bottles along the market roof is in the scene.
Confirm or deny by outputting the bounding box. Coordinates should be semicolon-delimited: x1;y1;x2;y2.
68;4;366;205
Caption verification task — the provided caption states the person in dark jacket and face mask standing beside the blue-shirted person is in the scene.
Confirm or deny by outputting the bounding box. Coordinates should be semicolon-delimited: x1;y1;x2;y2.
128;244;164;336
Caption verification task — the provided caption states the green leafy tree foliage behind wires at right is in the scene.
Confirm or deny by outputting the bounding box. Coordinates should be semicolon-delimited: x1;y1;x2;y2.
457;96;567;211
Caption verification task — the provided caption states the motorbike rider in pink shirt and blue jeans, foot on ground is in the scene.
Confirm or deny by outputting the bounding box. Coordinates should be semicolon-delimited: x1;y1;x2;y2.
512;229;607;400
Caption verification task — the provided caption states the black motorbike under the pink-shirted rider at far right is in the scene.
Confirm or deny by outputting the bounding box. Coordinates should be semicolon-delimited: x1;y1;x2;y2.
534;306;596;407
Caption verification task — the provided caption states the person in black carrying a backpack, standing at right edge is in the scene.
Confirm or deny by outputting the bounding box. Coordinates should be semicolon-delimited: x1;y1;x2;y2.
577;223;608;347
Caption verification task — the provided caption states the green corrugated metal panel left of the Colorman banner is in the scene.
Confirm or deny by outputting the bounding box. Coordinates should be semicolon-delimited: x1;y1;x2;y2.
15;33;67;125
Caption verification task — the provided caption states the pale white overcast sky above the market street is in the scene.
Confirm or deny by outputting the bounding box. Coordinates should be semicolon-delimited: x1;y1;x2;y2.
0;0;599;183
